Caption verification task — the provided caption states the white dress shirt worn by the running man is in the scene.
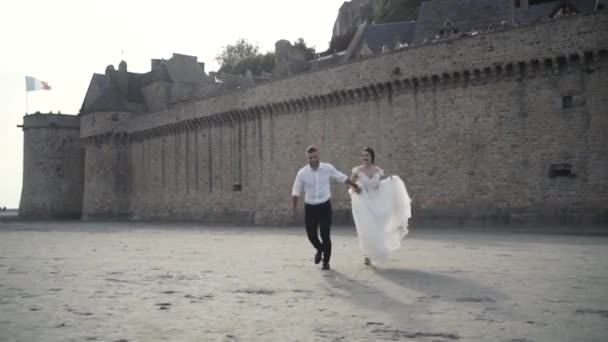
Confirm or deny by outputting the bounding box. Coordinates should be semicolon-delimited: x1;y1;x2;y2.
291;163;348;205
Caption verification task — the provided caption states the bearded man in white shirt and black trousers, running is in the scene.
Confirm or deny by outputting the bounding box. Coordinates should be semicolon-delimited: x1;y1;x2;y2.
291;146;361;270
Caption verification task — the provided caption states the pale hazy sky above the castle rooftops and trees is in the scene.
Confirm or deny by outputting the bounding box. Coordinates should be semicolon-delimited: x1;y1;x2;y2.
0;0;344;208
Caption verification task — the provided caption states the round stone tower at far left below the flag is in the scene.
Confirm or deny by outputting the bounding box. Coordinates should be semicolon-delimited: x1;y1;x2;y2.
19;114;84;218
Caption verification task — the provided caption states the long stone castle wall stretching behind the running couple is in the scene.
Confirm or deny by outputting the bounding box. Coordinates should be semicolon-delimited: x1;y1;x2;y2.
81;14;608;224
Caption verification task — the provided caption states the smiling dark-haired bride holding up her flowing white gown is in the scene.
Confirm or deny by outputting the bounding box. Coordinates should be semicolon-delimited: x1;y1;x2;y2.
349;147;412;266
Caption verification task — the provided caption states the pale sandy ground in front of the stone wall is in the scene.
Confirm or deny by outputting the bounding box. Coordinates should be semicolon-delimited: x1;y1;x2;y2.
0;222;608;342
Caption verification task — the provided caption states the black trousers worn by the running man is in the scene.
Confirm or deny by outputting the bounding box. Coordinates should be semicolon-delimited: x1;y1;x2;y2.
304;201;332;263
